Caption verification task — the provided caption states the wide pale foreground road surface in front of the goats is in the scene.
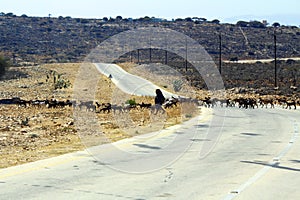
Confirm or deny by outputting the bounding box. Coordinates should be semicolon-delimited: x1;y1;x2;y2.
0;108;300;200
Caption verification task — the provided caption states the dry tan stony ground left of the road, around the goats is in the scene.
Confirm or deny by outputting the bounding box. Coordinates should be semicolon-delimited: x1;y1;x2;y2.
0;63;199;168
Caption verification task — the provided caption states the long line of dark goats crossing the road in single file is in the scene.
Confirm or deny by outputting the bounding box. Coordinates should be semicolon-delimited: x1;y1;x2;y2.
0;97;300;113
